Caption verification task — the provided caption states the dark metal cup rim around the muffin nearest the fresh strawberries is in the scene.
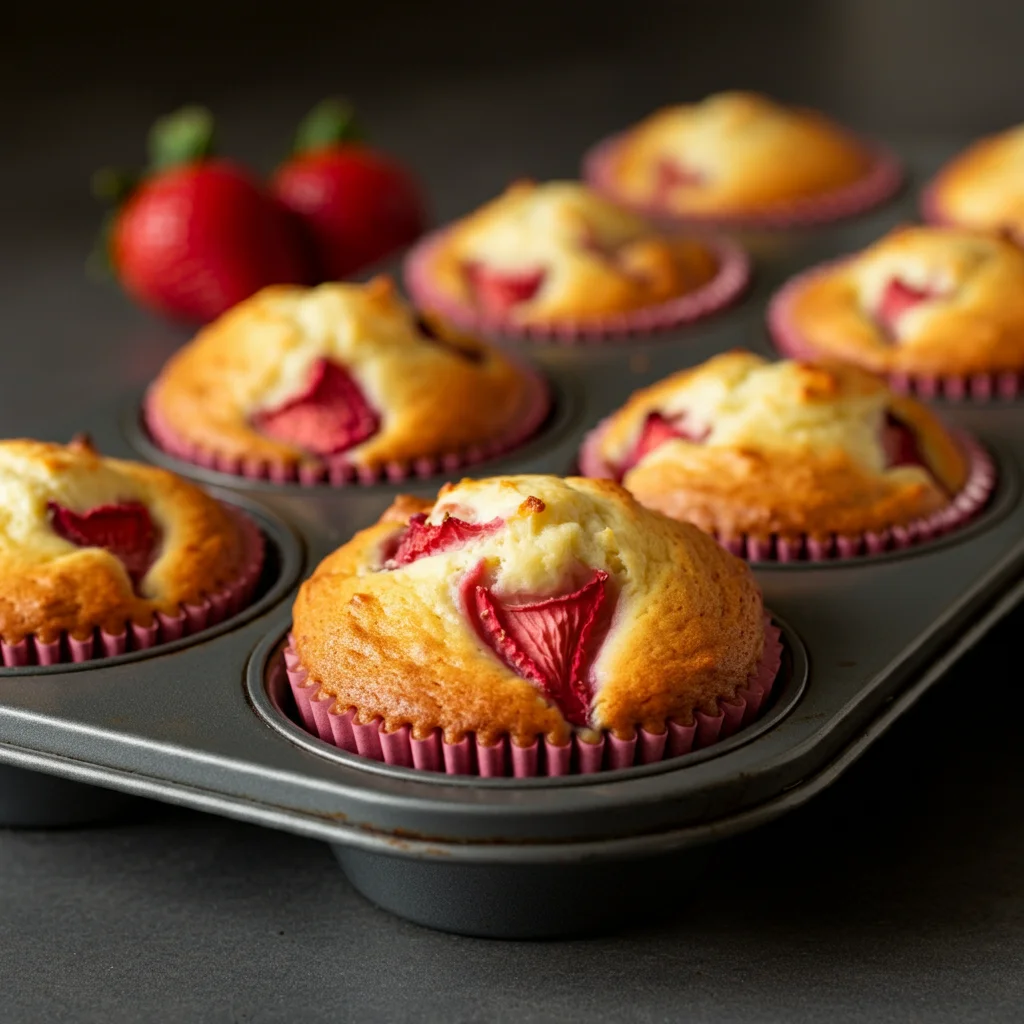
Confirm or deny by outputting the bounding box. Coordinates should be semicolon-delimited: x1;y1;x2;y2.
121;366;584;497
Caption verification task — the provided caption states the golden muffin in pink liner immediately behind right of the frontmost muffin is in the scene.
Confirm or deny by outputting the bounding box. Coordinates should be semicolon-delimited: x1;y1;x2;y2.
581;351;992;557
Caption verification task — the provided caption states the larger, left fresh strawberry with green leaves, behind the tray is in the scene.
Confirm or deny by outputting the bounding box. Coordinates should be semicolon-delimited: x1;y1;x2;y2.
94;108;310;322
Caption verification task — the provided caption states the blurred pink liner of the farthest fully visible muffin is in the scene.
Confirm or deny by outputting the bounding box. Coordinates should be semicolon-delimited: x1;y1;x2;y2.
583;131;903;228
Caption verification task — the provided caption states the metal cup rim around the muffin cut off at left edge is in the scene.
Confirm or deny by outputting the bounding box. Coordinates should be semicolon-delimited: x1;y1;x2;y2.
0;490;305;676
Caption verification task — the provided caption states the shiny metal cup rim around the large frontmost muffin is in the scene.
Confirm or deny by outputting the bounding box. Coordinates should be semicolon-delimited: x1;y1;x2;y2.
245;612;809;790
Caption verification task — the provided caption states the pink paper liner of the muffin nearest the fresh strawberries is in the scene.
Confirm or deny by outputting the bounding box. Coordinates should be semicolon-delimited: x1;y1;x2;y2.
142;361;551;487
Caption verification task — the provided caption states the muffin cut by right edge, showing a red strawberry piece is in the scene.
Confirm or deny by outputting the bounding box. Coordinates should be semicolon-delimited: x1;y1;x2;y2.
769;227;1024;393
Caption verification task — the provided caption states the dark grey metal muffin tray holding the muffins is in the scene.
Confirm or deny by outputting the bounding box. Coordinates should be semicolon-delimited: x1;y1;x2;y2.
0;148;1024;937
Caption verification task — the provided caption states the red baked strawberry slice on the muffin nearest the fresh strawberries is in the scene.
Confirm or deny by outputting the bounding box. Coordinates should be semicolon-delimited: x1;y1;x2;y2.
253;359;380;456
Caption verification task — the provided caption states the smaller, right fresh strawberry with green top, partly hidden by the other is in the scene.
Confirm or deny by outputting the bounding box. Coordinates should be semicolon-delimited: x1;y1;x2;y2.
271;99;427;281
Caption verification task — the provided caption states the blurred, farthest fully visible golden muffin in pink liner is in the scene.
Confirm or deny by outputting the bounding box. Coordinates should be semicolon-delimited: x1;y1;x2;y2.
586;92;900;223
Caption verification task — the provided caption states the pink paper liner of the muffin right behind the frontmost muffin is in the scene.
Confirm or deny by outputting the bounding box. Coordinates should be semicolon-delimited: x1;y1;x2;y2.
579;417;996;562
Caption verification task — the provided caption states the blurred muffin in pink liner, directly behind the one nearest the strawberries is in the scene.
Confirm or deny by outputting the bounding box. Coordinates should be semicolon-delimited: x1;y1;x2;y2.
397;181;745;334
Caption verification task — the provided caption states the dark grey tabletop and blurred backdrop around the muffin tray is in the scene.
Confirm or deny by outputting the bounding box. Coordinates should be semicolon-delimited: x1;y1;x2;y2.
0;0;1024;1022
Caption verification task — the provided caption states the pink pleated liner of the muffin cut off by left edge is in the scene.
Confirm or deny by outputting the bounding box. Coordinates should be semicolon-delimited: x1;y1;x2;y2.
0;509;265;669
